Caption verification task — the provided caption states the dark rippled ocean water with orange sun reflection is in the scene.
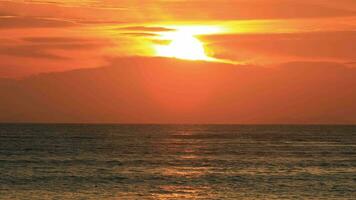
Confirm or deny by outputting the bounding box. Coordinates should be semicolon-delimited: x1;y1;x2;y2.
0;124;356;200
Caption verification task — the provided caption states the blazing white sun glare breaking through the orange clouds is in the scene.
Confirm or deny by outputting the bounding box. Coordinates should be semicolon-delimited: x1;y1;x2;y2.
155;27;221;61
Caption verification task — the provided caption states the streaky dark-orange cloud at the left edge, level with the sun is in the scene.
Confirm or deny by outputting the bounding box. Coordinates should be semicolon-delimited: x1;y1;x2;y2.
0;36;113;78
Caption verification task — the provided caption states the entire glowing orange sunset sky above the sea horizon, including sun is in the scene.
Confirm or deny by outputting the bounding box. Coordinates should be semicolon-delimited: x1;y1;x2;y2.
0;0;356;124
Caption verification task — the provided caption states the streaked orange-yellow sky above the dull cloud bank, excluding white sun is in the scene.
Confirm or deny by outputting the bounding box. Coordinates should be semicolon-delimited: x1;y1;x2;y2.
0;0;356;78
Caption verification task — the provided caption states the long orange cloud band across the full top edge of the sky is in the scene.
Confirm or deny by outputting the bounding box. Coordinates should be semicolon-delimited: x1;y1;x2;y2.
0;0;356;23
